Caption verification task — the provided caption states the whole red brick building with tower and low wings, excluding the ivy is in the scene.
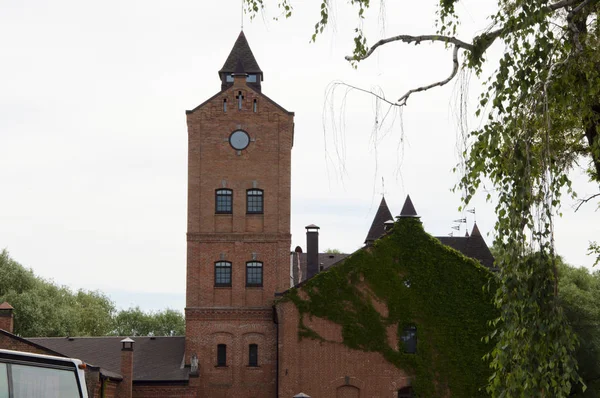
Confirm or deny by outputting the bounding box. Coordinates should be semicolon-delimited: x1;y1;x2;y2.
0;32;493;398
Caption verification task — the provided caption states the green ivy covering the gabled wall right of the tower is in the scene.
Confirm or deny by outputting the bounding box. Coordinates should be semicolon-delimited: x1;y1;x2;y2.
281;218;496;398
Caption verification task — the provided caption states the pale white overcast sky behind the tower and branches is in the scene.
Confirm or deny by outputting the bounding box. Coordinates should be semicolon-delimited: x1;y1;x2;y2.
0;0;600;309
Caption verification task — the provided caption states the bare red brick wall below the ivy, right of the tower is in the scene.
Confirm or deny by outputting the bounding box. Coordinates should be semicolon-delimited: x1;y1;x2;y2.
277;302;409;398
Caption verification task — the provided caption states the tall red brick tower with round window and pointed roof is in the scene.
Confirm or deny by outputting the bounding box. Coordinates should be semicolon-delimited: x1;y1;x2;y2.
185;32;294;398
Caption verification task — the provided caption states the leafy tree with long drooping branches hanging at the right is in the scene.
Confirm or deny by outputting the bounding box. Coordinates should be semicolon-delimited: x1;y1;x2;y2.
245;0;600;397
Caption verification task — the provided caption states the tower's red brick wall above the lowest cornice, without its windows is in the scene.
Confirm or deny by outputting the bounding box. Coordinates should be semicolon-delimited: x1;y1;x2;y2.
186;78;293;307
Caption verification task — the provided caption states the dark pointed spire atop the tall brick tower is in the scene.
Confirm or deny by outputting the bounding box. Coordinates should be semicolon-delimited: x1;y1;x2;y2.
219;31;263;91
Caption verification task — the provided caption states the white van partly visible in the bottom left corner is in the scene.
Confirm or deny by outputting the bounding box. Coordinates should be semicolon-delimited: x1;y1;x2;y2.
0;350;88;398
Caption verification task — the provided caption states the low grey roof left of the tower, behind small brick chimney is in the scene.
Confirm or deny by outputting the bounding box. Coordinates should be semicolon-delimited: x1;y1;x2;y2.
28;336;189;382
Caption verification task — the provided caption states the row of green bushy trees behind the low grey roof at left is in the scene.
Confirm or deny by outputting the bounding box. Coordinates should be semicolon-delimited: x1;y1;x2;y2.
0;250;185;337
